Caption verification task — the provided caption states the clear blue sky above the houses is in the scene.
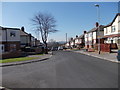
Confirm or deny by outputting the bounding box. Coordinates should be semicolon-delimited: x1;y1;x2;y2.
2;2;118;41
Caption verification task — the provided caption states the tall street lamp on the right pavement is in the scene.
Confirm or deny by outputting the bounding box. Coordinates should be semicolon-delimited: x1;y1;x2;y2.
95;4;100;54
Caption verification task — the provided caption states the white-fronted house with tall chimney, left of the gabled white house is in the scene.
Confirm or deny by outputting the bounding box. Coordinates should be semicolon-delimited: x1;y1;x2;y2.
84;25;104;49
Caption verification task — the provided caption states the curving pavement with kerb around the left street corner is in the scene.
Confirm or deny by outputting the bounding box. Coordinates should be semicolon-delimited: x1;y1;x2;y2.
0;52;52;67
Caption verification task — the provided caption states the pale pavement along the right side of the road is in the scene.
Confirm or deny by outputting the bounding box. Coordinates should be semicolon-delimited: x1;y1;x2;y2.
69;50;120;63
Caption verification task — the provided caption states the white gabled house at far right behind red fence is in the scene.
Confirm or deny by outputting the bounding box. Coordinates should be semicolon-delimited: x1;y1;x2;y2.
104;13;120;49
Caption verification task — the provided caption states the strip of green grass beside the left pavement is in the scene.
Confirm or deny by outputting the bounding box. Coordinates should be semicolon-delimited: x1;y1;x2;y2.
0;57;38;63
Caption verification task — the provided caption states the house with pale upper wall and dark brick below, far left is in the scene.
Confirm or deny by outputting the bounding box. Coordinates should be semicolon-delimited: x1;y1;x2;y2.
0;27;20;58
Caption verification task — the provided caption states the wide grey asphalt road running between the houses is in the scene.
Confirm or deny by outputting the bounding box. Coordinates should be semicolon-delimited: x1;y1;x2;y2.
2;51;118;88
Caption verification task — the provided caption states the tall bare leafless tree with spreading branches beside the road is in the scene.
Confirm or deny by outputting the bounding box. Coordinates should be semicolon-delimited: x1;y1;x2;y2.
32;12;58;54
